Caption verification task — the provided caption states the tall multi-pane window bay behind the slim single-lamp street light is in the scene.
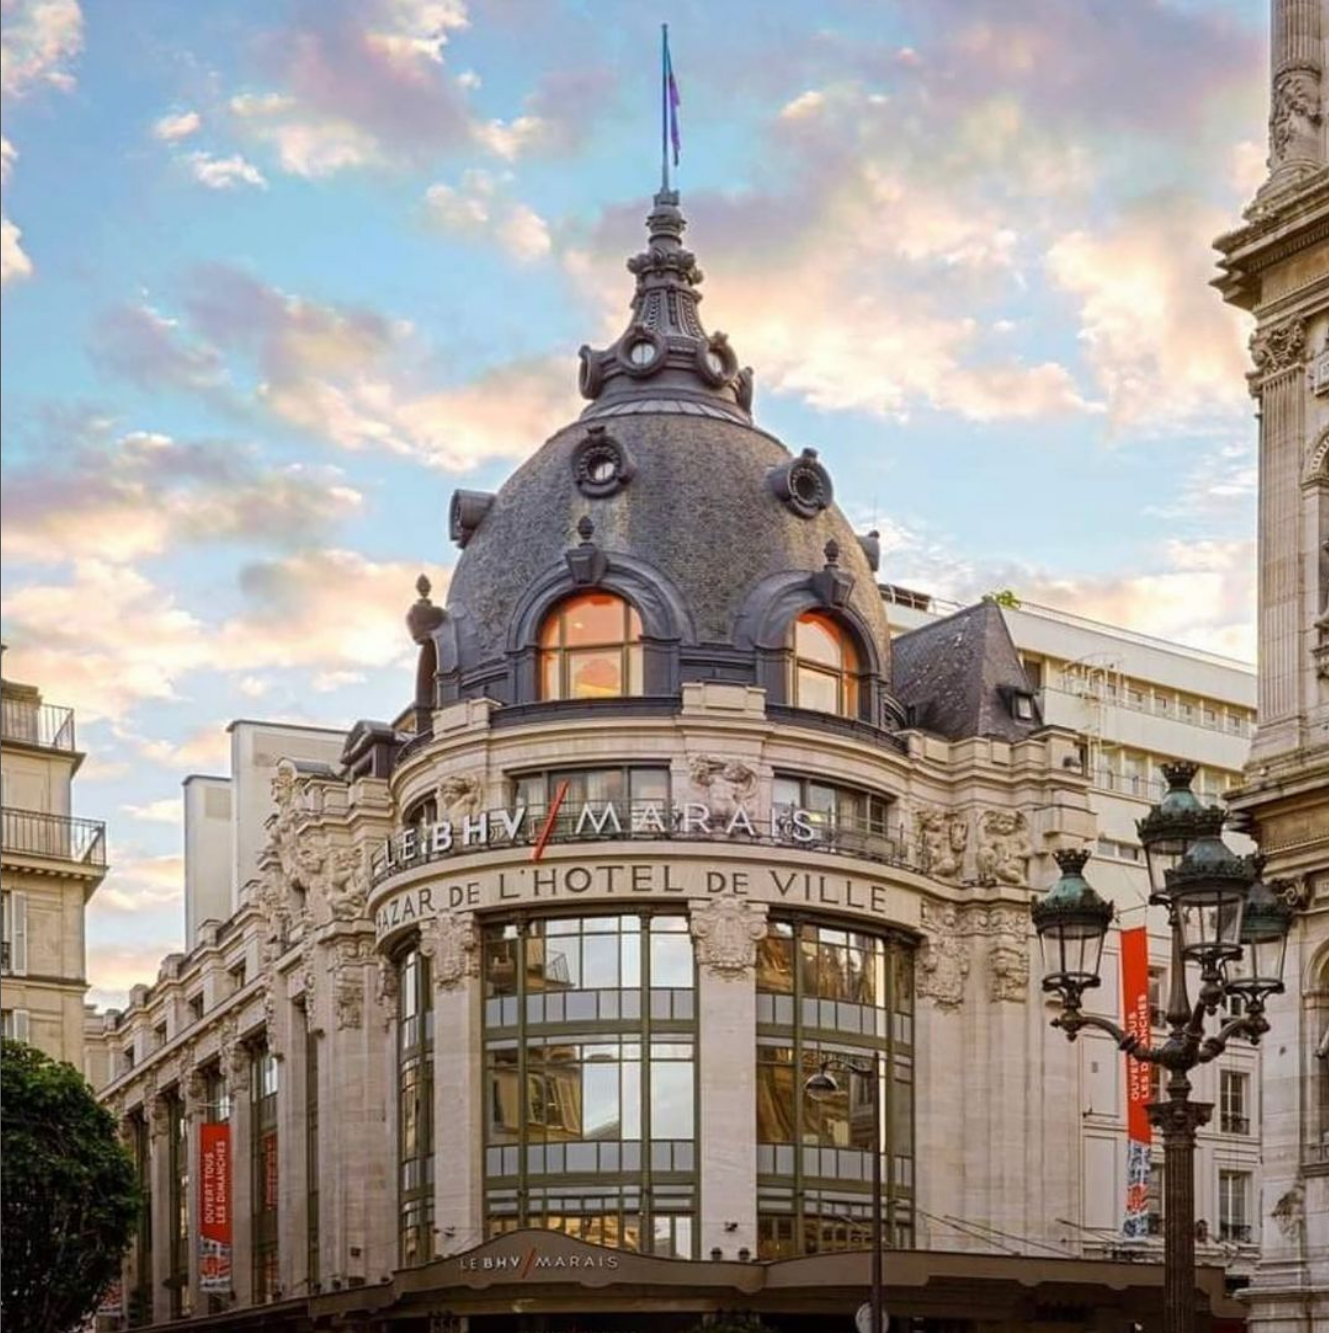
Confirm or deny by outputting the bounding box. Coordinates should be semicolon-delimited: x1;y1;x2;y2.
756;917;913;1258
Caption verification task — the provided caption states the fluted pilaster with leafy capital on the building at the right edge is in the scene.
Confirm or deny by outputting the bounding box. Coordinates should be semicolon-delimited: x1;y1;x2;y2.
1250;317;1306;757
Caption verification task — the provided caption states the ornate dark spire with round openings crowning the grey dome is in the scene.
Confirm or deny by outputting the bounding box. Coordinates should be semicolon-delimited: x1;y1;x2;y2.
581;189;752;423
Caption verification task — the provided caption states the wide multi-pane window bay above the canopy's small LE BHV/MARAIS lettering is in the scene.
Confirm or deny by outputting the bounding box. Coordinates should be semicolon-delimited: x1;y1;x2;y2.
484;912;697;1258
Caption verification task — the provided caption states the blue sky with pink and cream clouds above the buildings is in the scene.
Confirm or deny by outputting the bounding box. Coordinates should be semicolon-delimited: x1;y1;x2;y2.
0;0;1268;1002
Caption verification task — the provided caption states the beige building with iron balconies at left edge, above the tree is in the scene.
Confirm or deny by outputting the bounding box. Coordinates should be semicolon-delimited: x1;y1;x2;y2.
0;666;107;1070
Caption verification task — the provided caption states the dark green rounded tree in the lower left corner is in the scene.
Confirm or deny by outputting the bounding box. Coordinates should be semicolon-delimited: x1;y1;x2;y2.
0;1041;139;1333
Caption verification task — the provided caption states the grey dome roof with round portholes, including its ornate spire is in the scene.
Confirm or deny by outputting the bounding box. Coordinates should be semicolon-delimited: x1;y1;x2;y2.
429;192;897;725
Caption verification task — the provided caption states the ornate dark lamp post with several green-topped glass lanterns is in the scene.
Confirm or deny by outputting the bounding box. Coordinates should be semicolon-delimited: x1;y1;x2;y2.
1032;764;1292;1333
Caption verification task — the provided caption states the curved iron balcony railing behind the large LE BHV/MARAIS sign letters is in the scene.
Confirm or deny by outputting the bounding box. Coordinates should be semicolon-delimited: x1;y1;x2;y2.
371;801;920;884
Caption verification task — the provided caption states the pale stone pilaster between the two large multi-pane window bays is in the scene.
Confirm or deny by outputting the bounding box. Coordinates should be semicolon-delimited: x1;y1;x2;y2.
690;897;766;1260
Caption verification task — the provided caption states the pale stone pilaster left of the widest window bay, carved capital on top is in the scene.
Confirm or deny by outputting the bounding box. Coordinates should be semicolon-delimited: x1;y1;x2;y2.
420;912;484;1254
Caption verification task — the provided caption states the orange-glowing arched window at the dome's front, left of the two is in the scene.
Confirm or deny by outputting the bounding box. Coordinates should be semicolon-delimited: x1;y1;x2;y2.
540;592;641;698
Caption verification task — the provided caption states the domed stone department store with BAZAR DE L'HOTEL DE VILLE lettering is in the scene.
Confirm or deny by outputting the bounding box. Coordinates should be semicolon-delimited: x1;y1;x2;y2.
89;193;1233;1333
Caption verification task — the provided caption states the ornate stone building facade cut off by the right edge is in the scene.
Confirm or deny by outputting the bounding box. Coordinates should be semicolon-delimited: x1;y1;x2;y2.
1216;0;1329;1333
